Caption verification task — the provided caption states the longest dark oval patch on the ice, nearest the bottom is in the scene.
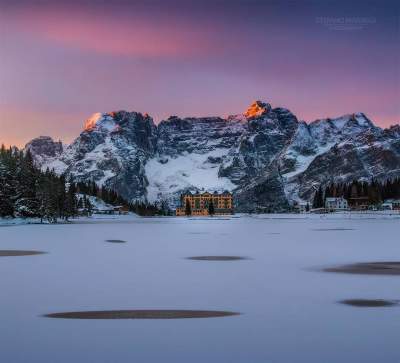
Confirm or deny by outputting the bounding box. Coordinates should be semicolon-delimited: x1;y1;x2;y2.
44;310;240;319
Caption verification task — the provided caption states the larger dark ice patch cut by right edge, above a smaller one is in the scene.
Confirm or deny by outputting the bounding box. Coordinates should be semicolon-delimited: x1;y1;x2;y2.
323;261;400;275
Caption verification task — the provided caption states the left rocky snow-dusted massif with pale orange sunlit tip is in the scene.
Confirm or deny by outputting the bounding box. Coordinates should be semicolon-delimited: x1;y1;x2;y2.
37;111;157;199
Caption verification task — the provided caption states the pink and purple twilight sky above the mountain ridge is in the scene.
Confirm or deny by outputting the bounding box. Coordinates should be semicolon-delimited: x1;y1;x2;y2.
0;0;400;146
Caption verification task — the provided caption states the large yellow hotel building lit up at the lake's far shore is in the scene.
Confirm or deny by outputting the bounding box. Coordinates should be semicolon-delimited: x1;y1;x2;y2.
176;192;233;216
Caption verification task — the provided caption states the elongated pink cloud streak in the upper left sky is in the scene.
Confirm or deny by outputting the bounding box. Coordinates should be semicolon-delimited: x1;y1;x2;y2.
0;8;220;58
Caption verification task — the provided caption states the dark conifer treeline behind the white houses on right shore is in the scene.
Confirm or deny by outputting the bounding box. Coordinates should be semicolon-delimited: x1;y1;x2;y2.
312;178;400;208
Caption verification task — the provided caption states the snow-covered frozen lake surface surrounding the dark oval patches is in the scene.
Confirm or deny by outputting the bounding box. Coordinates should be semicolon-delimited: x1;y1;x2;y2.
0;215;400;363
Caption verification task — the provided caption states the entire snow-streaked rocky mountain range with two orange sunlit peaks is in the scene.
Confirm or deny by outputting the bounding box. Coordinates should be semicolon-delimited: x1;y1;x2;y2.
26;101;400;211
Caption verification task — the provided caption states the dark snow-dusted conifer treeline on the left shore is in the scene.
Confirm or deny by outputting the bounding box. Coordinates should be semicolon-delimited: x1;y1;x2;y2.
0;145;172;223
